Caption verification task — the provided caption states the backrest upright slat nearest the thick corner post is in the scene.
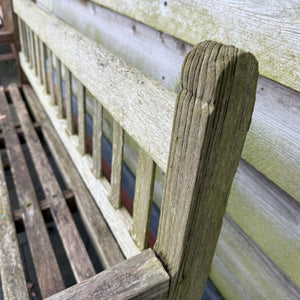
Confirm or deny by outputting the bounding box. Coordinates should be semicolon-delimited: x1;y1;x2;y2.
132;149;155;250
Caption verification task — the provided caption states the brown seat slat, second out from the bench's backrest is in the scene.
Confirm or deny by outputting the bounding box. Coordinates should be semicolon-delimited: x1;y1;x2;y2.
9;84;96;282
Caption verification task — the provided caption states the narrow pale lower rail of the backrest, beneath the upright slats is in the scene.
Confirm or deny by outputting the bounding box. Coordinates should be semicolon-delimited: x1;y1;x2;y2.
20;54;140;258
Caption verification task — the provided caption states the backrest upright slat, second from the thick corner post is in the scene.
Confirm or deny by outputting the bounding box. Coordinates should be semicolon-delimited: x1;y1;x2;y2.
109;121;124;208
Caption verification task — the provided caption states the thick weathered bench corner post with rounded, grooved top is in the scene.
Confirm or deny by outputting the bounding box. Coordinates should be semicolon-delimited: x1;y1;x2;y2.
155;41;258;299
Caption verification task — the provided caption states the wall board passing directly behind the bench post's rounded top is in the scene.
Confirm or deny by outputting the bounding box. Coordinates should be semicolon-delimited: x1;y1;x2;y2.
34;0;300;202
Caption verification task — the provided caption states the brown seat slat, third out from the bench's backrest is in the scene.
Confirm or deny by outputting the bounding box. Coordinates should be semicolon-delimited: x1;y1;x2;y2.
0;88;64;297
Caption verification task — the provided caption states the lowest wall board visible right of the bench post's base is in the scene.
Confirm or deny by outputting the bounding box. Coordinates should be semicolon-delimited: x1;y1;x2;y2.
210;216;300;300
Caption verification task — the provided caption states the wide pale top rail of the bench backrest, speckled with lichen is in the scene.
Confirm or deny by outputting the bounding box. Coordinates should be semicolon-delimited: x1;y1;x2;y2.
14;0;176;170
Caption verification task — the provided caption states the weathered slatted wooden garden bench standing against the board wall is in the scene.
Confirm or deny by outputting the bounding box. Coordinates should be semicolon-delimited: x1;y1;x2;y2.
0;0;258;299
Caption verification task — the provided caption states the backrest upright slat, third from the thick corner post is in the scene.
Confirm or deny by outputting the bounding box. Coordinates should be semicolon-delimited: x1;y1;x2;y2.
93;98;102;178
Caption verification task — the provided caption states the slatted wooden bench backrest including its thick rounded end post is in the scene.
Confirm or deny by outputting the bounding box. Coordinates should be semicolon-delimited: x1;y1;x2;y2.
14;0;258;299
